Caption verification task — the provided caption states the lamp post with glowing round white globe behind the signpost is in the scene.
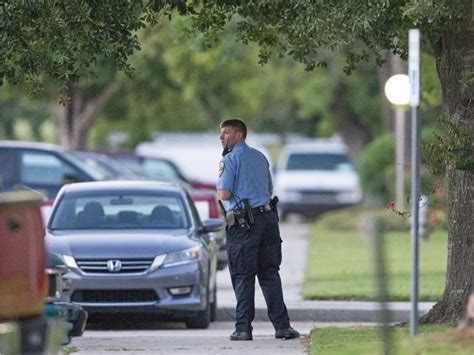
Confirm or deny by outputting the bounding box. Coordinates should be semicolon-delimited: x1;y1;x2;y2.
384;74;410;211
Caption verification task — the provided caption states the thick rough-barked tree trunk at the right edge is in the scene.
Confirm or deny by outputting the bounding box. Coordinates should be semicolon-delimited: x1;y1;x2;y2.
421;0;474;323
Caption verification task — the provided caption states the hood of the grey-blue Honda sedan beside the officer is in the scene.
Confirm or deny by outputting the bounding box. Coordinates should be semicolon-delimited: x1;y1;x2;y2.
46;230;198;258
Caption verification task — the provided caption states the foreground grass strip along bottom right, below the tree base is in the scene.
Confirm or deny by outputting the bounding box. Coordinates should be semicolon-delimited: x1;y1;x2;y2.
309;325;474;355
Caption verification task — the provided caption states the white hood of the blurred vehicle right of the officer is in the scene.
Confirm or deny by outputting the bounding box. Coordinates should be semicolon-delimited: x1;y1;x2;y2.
275;170;359;191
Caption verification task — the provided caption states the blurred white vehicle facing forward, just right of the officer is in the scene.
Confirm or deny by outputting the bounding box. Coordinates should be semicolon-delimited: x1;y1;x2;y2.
274;139;362;218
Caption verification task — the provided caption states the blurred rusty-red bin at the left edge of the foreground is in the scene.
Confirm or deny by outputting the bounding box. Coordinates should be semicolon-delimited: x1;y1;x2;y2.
0;191;48;321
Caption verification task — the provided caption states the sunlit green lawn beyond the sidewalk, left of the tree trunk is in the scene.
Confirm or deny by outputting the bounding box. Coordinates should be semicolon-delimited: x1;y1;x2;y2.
303;223;447;301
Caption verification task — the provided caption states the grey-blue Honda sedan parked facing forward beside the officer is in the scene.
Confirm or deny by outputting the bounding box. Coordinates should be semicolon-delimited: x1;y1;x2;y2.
46;181;222;328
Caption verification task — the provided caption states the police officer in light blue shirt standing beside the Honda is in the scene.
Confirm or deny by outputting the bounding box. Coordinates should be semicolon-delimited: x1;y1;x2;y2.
217;119;299;340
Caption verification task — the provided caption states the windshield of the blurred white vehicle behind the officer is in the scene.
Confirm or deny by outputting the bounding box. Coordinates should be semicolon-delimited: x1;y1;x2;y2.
286;153;353;170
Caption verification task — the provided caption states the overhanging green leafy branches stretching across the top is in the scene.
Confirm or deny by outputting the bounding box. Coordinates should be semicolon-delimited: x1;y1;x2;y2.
0;0;463;89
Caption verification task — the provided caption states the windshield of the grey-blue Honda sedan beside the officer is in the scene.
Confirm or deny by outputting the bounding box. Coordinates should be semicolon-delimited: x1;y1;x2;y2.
50;191;190;230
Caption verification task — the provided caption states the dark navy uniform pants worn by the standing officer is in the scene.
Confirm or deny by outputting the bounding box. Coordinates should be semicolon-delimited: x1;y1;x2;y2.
226;211;290;332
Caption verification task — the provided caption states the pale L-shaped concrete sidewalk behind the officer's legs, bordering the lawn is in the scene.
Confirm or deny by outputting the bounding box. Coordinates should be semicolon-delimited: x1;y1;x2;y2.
217;223;434;323
